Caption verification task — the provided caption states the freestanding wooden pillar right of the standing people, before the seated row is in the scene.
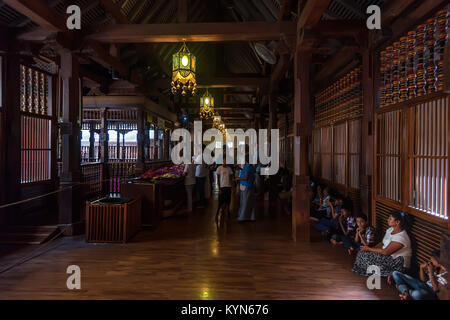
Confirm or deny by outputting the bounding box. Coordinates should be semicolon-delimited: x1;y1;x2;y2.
292;51;312;242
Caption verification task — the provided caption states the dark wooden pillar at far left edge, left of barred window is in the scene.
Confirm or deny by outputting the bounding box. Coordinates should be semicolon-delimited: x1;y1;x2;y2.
2;51;21;223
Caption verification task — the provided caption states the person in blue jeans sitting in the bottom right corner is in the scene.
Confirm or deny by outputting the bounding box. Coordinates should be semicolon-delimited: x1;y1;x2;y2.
388;251;448;300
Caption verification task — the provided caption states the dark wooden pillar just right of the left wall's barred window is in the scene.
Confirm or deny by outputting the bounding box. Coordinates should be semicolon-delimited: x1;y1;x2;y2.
59;49;83;235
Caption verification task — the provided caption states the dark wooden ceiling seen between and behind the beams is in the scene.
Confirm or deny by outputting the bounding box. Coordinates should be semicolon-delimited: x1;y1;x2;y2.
0;0;445;127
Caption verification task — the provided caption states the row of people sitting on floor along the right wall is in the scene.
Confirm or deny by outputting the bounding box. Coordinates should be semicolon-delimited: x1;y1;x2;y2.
311;186;447;300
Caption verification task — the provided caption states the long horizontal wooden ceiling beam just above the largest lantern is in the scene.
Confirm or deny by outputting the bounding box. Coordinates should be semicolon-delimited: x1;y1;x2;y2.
88;21;296;43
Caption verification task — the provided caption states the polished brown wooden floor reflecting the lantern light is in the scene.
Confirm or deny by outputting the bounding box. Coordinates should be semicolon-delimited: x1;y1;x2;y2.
0;192;397;300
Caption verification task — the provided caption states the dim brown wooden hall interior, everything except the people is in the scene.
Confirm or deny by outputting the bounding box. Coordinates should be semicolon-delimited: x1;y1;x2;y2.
0;0;450;300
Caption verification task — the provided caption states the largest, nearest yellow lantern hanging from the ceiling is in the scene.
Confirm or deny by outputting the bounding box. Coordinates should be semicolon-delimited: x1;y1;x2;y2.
171;43;197;96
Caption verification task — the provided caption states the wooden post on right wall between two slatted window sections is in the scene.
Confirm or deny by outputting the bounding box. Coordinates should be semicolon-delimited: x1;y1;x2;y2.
360;42;377;221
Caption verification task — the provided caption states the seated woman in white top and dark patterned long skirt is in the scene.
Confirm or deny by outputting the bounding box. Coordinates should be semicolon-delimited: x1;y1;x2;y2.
352;211;412;277
